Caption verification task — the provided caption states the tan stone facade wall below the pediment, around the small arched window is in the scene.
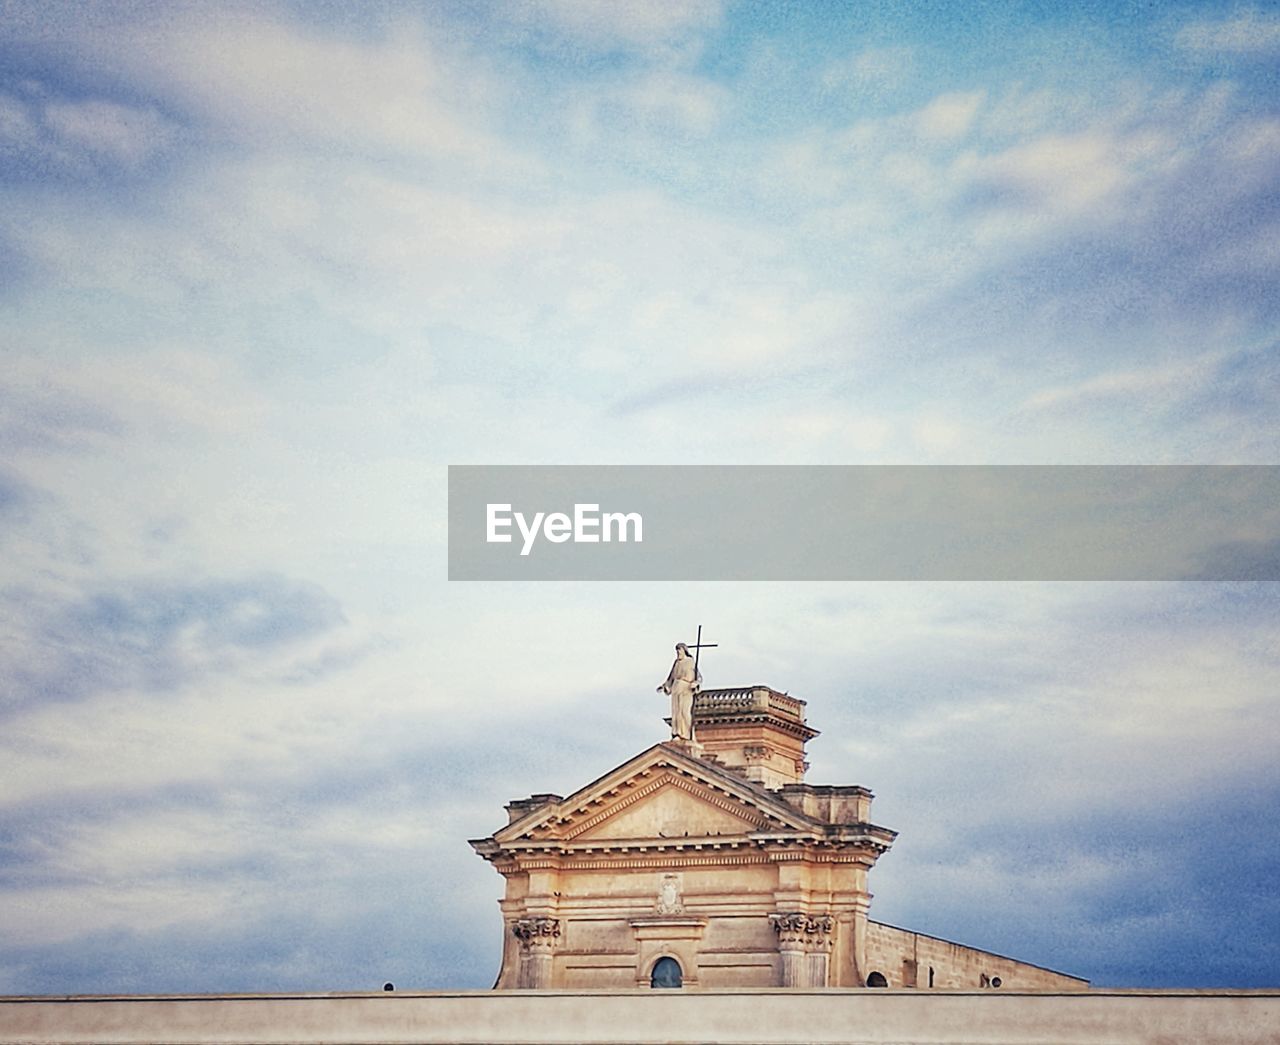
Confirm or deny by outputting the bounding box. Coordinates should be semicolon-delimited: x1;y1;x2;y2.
498;853;865;990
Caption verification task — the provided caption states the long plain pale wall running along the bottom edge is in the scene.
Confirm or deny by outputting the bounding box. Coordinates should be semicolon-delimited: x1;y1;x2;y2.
0;990;1280;1045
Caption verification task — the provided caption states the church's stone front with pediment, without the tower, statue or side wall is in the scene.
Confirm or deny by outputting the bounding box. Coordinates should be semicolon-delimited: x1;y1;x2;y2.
472;744;893;989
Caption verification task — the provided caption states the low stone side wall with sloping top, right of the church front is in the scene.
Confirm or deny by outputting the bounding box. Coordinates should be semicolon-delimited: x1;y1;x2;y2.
867;921;1089;990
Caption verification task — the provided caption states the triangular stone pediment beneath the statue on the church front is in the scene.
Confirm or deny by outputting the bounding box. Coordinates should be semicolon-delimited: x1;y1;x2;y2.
494;744;813;844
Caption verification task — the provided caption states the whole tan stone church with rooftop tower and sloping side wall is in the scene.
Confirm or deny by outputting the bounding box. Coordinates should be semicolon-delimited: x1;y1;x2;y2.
471;686;1088;991
